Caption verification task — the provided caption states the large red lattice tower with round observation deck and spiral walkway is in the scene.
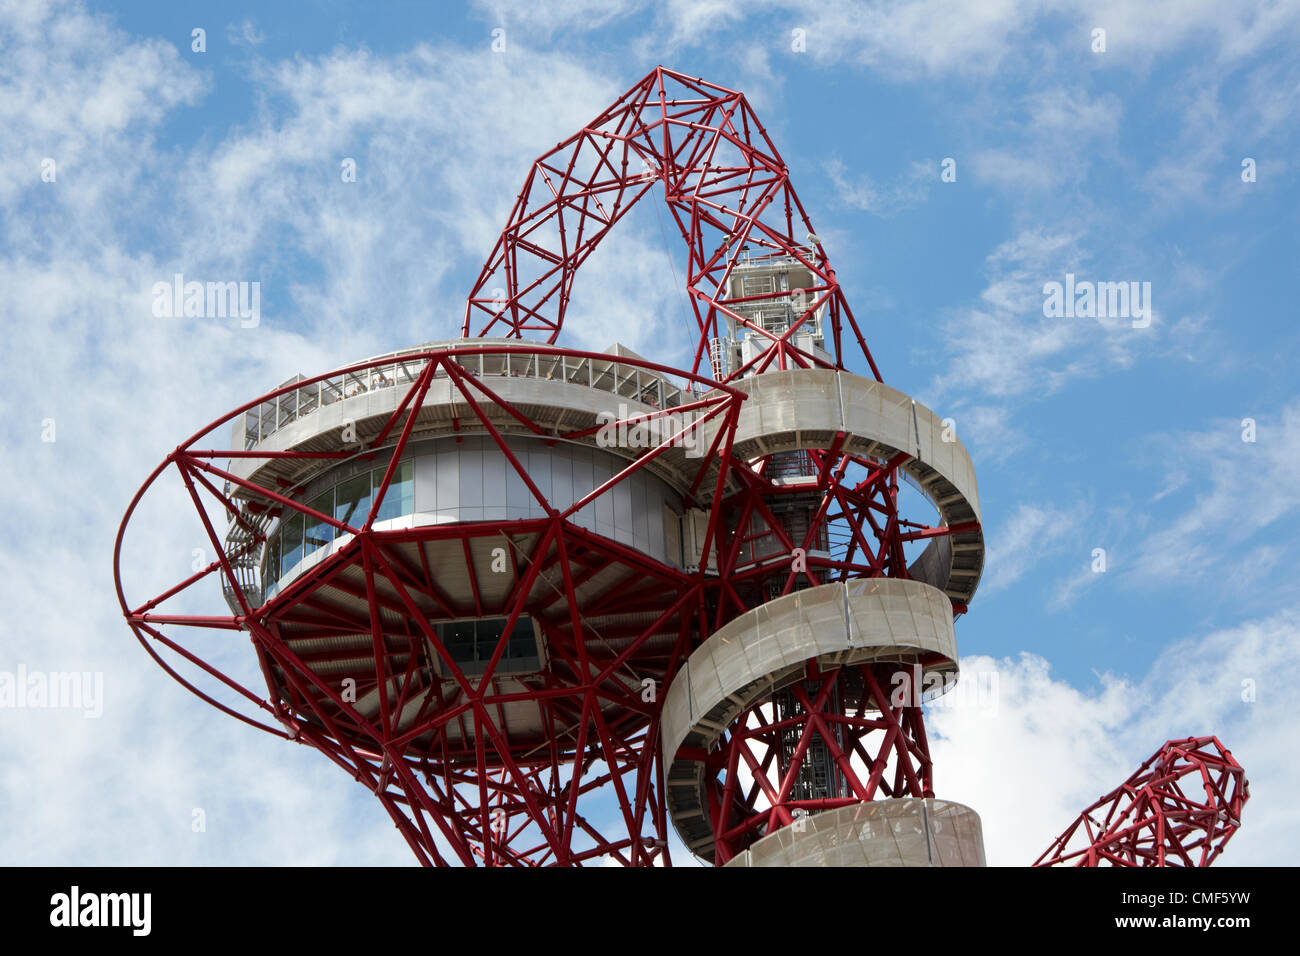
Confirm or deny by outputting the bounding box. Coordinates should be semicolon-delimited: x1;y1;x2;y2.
114;68;983;865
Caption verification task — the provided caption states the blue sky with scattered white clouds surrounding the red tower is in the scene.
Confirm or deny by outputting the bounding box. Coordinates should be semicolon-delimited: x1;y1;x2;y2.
0;0;1300;864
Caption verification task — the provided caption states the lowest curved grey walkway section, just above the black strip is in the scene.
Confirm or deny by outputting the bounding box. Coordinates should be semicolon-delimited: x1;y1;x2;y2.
727;797;985;866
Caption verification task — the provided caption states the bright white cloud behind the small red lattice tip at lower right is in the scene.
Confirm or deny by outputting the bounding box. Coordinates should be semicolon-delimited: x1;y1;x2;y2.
927;609;1300;866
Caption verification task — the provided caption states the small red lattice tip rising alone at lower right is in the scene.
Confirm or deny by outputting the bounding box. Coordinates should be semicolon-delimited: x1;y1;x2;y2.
1034;736;1249;866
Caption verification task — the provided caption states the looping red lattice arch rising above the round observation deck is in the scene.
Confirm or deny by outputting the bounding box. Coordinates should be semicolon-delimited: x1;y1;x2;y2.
463;68;880;381
